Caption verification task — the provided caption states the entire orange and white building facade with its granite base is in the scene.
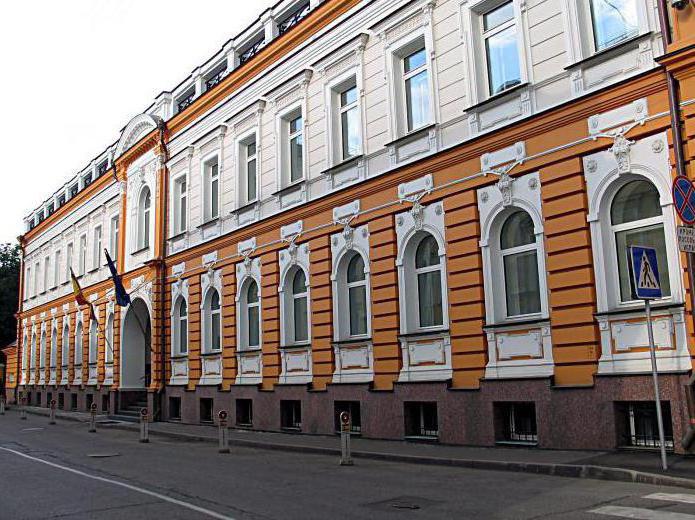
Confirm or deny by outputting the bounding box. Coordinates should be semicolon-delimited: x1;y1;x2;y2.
17;0;695;452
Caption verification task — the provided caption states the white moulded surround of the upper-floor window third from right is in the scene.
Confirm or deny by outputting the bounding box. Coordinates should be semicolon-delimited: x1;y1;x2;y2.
385;30;439;140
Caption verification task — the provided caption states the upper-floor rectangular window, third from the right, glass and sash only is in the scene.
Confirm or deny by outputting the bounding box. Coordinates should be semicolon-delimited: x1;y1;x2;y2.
403;45;430;132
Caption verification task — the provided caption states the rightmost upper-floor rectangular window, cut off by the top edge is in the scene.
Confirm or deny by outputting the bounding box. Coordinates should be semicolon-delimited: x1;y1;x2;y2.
589;0;639;51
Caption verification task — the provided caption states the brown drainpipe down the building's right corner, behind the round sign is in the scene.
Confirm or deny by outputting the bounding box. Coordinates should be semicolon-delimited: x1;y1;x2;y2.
657;0;695;450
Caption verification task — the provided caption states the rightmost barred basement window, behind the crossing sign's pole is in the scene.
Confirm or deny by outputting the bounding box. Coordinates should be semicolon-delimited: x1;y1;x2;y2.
616;401;673;450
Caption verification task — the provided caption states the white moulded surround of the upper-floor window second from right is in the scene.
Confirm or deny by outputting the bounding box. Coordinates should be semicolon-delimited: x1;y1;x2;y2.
461;0;528;105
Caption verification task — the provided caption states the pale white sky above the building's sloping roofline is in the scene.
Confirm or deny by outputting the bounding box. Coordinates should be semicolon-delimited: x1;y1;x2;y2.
0;0;274;242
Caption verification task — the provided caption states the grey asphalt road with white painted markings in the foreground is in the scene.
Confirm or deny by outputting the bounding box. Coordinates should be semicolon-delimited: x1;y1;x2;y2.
0;412;695;520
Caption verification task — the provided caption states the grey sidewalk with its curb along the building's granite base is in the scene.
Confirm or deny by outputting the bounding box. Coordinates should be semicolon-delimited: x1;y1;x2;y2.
9;406;695;489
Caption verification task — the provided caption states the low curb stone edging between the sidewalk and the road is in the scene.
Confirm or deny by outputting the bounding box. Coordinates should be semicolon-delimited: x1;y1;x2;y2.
14;408;695;489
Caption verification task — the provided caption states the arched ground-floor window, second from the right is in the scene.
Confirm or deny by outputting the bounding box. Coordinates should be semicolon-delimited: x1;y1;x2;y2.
499;210;541;317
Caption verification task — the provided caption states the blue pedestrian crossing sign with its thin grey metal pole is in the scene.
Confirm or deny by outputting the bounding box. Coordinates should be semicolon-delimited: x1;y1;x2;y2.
628;246;668;471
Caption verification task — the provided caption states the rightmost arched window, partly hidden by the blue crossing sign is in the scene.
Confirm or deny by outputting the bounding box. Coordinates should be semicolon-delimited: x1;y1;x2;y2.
610;180;671;302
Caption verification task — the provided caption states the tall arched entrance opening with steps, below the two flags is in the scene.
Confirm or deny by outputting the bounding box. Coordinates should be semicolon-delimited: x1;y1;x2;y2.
120;298;152;390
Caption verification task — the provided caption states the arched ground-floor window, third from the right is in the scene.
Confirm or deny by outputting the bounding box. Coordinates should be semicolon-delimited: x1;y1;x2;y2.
415;233;444;328
